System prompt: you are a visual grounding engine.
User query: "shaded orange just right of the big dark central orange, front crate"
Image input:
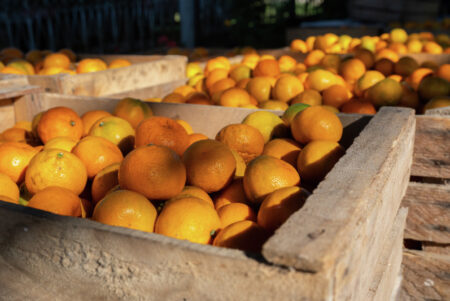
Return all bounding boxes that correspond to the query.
[183,139,236,193]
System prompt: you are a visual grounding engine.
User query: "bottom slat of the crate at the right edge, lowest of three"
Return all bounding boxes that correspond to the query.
[398,250,450,301]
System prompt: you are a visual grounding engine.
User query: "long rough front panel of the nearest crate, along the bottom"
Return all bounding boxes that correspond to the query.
[0,202,327,300]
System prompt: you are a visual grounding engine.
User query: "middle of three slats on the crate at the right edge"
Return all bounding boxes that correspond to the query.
[402,182,450,244]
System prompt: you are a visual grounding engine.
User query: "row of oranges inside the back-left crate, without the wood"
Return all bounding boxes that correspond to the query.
[0,48,131,75]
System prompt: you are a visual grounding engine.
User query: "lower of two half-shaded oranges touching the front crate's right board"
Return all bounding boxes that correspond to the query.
[257,186,310,232]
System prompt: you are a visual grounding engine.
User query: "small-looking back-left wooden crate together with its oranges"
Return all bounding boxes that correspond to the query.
[0,48,186,96]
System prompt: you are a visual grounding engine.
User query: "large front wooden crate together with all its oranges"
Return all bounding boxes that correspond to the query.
[0,86,415,300]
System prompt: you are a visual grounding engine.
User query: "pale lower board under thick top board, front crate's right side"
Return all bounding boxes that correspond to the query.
[366,208,408,301]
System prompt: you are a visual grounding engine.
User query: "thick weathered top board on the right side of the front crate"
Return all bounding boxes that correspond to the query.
[263,108,415,300]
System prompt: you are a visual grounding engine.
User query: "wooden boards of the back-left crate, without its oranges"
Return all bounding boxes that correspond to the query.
[0,55,187,96]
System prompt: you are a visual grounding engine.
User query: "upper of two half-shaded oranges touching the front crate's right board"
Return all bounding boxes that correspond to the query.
[297,140,345,182]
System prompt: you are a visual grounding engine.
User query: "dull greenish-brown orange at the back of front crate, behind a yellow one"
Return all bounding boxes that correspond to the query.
[114,97,153,129]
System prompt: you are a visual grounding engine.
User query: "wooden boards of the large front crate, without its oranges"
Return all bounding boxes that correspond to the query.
[0,93,415,300]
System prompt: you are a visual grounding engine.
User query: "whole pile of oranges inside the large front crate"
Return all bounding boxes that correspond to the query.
[0,98,344,252]
